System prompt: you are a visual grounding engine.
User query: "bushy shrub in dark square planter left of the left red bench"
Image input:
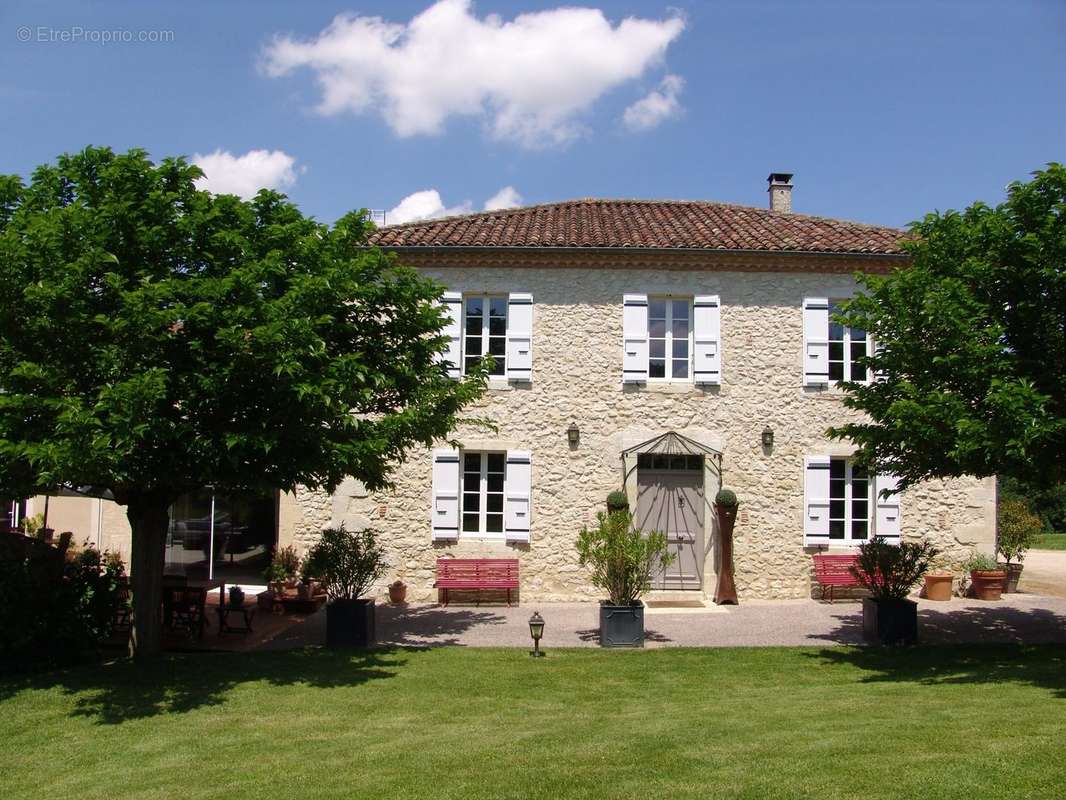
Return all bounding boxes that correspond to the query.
[304,526,387,647]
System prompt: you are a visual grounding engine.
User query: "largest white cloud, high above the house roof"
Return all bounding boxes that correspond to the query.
[262,0,684,147]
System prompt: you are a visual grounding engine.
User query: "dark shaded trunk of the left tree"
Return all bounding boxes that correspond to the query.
[126,495,171,659]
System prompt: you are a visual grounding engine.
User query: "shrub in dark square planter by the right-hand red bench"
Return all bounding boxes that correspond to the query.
[852,537,937,644]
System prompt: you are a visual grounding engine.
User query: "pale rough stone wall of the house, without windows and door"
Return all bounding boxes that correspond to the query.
[279,263,996,602]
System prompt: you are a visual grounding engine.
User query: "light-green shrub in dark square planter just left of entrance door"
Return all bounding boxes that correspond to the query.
[577,511,674,647]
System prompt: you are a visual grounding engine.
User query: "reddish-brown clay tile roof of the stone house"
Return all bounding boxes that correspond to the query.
[371,198,907,255]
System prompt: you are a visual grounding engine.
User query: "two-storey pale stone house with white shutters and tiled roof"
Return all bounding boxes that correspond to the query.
[12,174,996,602]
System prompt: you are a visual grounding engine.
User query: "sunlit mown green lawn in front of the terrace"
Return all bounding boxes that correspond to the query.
[0,646,1066,800]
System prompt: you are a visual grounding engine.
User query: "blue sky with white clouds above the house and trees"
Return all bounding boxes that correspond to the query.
[0,0,1066,225]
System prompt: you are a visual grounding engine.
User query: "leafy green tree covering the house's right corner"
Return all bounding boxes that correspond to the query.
[830,163,1066,486]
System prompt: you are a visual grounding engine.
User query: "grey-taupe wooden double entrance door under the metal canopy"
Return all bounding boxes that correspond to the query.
[633,454,704,591]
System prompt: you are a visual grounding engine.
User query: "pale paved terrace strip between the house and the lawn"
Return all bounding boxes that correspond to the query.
[255,593,1066,650]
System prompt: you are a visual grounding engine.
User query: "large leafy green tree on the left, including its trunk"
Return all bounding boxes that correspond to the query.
[0,147,484,655]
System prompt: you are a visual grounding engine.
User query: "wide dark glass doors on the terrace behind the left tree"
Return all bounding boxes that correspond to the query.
[165,489,277,583]
